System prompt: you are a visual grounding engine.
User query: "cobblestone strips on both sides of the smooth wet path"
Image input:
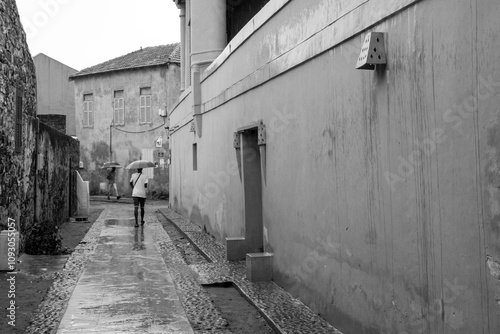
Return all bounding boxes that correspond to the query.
[25,204,341,334]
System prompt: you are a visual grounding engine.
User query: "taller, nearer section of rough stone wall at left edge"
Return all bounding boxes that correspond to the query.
[0,0,36,246]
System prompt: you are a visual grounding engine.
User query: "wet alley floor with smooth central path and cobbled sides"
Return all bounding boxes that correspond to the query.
[20,202,340,334]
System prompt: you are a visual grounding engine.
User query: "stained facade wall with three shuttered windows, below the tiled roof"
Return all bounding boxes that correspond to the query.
[74,65,179,195]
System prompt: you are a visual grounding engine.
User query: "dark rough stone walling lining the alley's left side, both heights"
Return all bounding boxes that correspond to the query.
[0,0,79,253]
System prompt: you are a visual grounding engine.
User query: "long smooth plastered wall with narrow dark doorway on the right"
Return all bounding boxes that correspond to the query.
[170,0,500,333]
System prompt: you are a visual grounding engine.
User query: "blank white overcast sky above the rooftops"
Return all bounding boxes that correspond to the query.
[16,0,180,71]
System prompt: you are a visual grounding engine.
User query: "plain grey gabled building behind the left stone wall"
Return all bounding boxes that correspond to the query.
[33,53,78,136]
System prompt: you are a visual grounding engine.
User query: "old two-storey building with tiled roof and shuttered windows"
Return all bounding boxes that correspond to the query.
[70,44,180,195]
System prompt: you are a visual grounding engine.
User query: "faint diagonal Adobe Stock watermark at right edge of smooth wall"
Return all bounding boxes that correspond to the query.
[384,74,500,192]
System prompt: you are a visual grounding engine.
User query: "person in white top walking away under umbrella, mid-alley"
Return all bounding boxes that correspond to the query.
[125,160,155,227]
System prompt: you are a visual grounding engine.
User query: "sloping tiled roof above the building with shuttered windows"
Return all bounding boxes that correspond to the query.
[69,43,180,80]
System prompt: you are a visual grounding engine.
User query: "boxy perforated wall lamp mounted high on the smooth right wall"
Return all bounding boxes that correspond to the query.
[356,32,387,70]
